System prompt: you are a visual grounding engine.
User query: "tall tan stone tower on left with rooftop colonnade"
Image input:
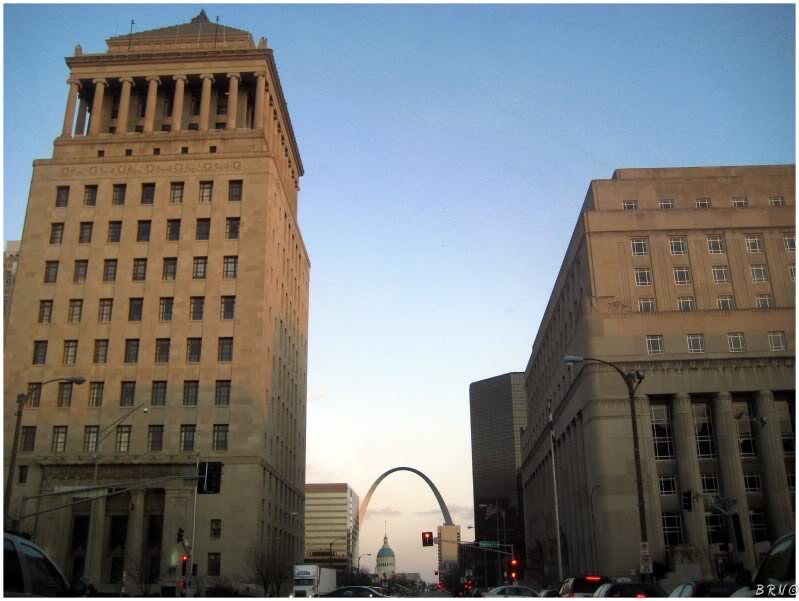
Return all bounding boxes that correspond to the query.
[5,12,310,594]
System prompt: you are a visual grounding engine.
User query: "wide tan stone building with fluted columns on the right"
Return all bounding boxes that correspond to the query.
[522,166,796,580]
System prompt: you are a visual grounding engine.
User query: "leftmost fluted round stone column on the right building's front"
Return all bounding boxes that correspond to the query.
[671,392,713,576]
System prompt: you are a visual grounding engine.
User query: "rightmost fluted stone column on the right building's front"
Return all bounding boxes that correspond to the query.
[753,390,794,541]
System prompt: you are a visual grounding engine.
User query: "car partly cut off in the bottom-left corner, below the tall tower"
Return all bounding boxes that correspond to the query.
[3,532,88,597]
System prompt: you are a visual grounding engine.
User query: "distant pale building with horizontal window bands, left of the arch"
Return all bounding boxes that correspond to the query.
[305,483,360,572]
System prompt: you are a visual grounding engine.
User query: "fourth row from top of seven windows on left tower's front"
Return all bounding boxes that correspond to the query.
[39,296,236,323]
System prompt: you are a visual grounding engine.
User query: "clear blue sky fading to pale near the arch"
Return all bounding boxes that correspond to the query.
[4,4,796,580]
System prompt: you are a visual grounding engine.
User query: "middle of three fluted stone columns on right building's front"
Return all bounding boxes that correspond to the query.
[713,392,759,574]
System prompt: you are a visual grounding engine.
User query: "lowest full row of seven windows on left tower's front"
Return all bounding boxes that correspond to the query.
[19,424,230,453]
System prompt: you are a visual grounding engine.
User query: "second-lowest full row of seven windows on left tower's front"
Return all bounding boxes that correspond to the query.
[26,380,232,409]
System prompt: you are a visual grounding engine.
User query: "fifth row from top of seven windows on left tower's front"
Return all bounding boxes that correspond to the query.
[33,337,238,365]
